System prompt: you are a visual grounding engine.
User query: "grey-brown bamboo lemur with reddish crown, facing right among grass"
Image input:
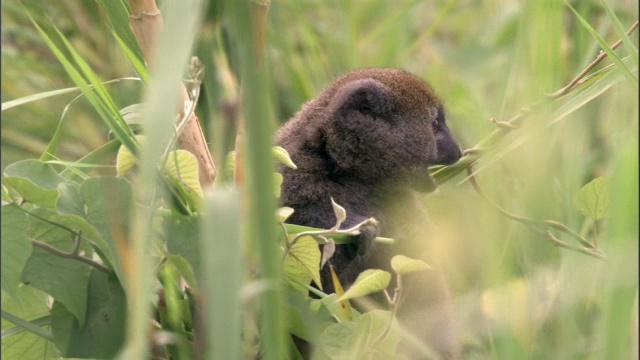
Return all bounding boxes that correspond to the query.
[276,68,461,359]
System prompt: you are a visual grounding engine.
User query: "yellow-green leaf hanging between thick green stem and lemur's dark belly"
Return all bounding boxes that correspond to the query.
[282,236,322,294]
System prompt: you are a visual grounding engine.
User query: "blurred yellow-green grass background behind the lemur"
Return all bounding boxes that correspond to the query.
[1,0,638,359]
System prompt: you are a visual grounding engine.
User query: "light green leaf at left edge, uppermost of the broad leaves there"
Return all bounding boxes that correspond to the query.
[2,159,67,208]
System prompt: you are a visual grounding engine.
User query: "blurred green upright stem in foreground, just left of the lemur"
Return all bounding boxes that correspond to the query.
[225,0,286,360]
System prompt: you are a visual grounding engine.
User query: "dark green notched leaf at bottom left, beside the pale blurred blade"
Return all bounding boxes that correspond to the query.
[51,269,127,359]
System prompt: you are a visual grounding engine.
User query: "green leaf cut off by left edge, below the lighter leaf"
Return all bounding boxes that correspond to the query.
[0,205,32,298]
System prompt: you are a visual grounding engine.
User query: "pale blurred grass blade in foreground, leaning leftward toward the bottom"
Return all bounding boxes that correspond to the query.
[119,0,205,359]
